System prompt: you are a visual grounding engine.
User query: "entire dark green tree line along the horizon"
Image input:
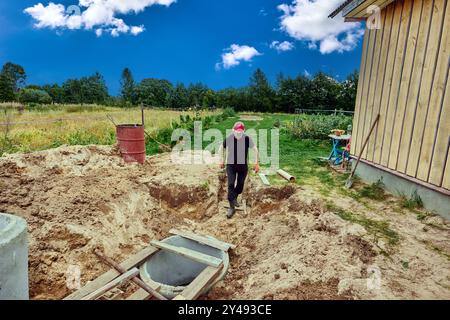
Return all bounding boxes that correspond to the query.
[0,63,358,113]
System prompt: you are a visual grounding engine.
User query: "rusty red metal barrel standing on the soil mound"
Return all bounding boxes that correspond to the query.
[116,124,145,164]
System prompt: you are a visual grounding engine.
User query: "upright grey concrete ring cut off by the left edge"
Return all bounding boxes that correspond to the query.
[0,213,29,300]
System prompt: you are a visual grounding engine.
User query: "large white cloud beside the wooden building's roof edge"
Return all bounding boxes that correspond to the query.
[278,0,364,54]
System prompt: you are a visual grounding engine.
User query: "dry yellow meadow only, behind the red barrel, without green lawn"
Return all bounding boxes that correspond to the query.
[0,105,218,155]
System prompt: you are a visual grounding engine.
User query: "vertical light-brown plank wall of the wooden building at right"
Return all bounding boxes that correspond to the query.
[351,0,450,190]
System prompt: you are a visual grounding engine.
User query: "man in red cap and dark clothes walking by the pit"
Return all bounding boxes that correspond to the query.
[219,122,259,219]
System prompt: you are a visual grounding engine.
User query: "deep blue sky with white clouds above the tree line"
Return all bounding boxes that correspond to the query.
[0,0,363,94]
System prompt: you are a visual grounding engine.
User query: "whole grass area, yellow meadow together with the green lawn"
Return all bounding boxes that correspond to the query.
[0,105,352,192]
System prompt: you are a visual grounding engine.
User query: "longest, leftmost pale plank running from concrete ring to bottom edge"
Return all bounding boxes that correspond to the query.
[64,246,159,300]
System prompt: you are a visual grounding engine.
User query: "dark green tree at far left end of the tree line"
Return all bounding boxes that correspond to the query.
[0,62,27,102]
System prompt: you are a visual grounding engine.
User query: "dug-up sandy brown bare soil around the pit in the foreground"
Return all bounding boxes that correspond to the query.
[0,146,450,299]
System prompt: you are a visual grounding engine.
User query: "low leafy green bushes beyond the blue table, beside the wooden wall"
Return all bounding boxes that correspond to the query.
[288,115,353,140]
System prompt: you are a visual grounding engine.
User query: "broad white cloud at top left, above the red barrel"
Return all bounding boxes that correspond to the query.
[24,0,176,37]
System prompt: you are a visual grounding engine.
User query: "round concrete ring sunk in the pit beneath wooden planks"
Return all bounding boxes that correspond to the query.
[140,236,230,299]
